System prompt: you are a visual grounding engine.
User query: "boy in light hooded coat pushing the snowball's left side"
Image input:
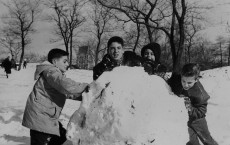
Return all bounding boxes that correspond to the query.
[22,49,88,145]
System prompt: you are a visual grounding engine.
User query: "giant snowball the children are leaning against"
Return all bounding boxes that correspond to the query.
[68,66,188,145]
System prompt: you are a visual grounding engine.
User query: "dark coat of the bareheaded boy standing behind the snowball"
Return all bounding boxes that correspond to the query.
[93,51,141,80]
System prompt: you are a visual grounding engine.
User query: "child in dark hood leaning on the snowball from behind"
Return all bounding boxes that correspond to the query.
[141,42,167,79]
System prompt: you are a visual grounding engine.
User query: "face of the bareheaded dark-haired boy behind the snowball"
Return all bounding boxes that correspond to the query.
[108,42,124,60]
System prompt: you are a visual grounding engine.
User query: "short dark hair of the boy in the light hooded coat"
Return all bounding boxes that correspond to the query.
[48,48,69,63]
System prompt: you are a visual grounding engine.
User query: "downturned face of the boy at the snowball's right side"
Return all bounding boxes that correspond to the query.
[181,76,197,90]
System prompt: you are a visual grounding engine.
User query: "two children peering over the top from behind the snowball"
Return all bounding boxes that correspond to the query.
[93,36,167,80]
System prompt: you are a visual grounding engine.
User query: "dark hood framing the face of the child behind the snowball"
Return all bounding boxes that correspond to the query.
[141,42,161,63]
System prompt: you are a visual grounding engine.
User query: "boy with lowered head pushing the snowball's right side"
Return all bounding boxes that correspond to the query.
[169,63,217,145]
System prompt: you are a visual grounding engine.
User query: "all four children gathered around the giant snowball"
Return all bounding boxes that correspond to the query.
[22,36,217,145]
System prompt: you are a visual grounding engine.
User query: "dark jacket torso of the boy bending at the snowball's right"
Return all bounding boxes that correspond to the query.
[188,81,210,120]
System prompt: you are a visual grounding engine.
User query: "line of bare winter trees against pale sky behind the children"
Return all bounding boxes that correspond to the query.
[0,0,230,72]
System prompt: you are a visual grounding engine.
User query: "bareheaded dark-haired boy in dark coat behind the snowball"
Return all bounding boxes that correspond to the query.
[93,36,141,80]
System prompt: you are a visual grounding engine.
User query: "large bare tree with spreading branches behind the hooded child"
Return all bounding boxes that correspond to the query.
[98,0,205,73]
